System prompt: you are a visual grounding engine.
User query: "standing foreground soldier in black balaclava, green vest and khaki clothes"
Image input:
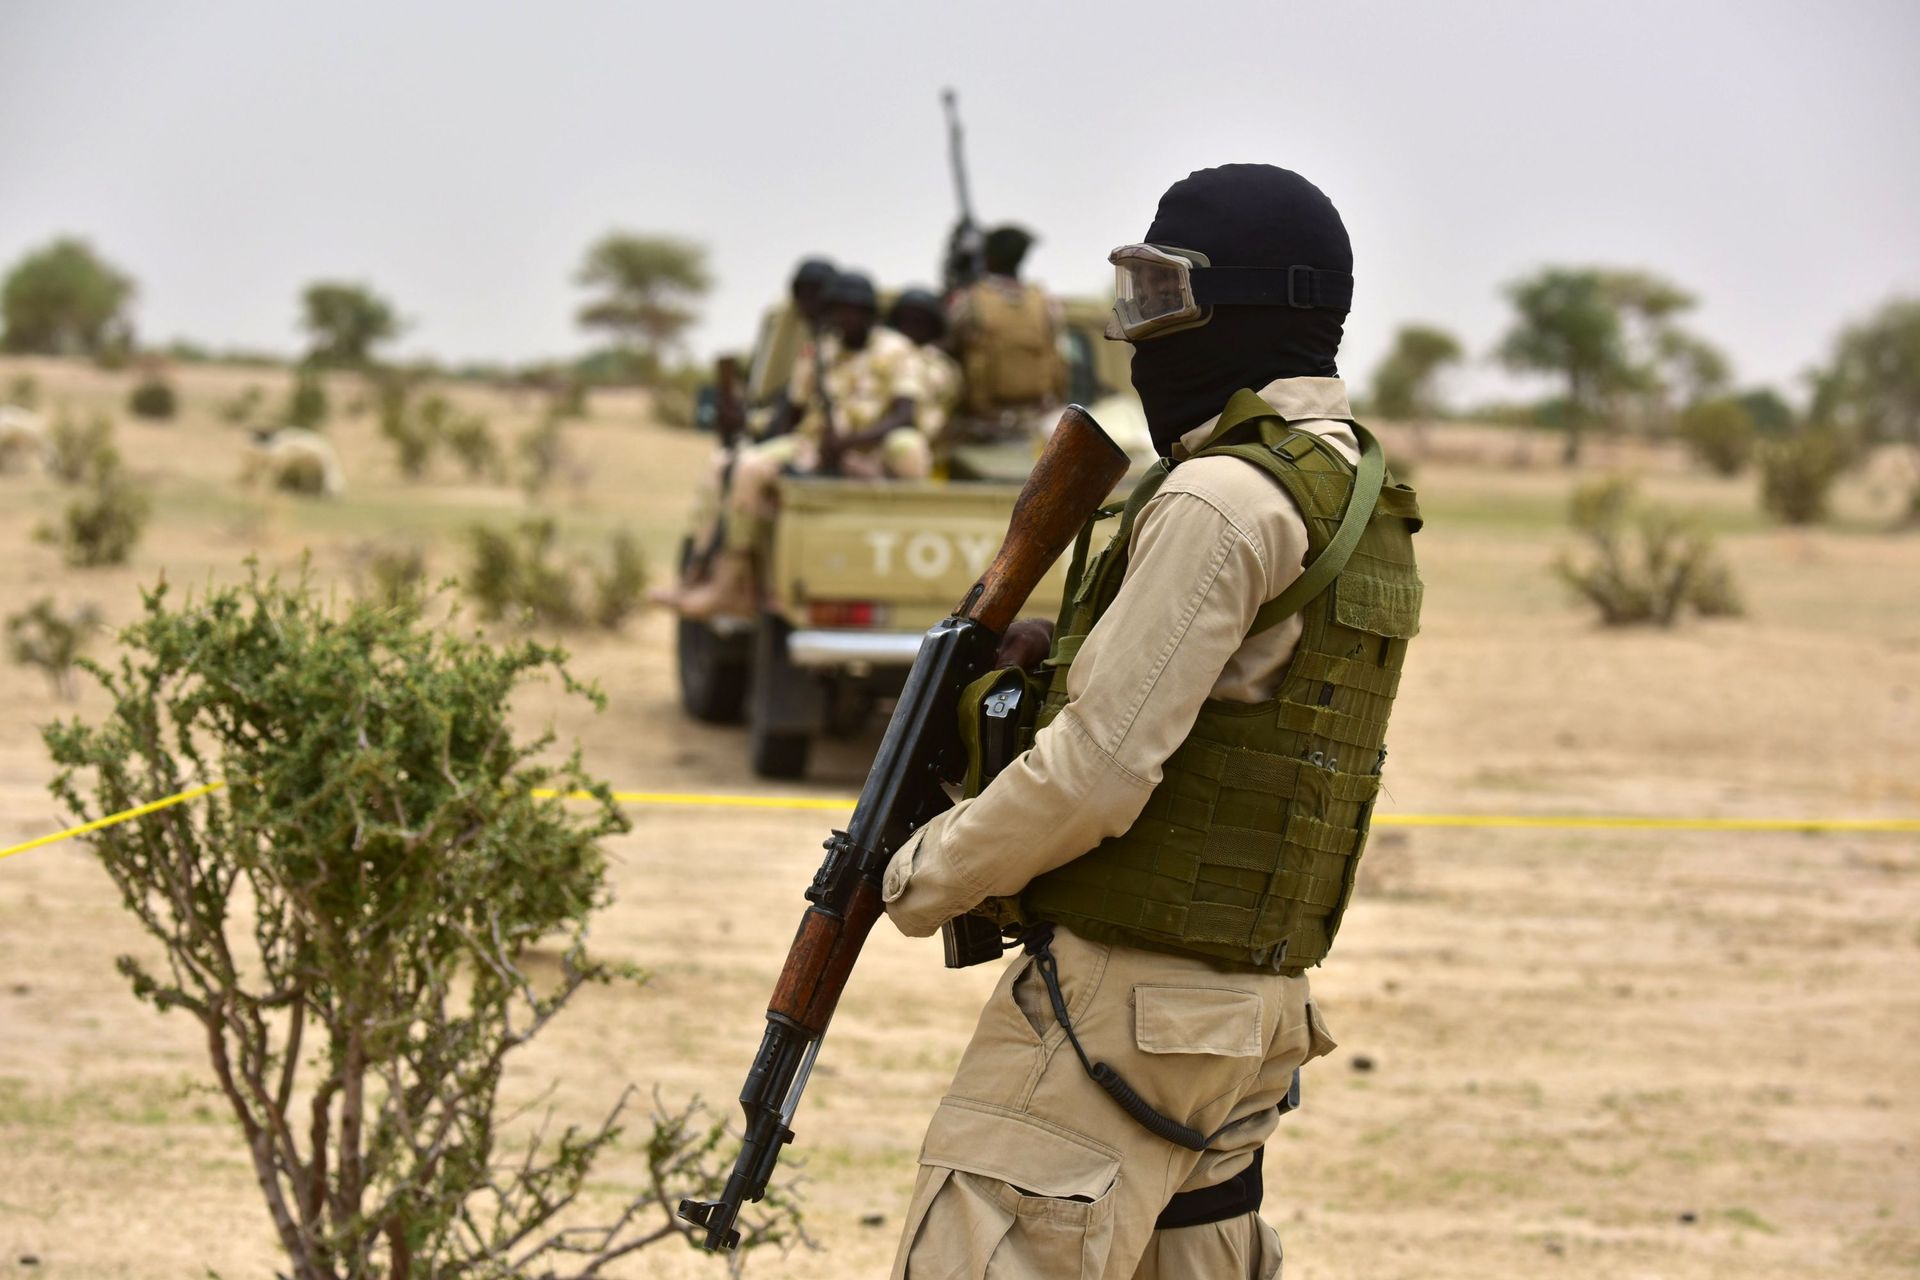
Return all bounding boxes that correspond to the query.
[883,165,1421,1280]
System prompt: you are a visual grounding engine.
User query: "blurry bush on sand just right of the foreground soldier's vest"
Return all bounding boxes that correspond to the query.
[1553,476,1743,628]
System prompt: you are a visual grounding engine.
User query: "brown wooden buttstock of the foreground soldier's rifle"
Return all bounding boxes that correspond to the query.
[956,405,1127,635]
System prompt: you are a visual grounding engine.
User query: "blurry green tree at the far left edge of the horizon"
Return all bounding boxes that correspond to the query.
[0,238,134,355]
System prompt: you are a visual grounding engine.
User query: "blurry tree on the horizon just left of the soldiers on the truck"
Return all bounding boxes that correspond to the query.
[574,230,712,367]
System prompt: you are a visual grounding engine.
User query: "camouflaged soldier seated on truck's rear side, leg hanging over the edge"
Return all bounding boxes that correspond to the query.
[662,273,933,618]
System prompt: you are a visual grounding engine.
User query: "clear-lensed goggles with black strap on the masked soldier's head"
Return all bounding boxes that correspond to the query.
[1106,244,1354,342]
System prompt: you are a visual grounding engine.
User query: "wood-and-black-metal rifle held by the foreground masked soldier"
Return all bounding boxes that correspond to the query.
[680,405,1127,1249]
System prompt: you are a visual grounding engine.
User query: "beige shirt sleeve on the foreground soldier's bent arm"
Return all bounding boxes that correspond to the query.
[881,480,1306,936]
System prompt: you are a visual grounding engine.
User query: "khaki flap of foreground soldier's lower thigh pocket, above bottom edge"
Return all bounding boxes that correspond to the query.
[920,1098,1119,1199]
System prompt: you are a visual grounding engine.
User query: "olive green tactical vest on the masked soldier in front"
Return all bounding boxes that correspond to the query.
[983,391,1421,973]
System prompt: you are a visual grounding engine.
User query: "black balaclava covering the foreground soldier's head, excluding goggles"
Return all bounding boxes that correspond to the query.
[1133,165,1354,455]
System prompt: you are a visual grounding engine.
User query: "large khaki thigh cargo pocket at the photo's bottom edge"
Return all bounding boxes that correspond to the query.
[895,1098,1119,1280]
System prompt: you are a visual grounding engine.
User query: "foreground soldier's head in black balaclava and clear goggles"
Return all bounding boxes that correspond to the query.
[1108,165,1354,453]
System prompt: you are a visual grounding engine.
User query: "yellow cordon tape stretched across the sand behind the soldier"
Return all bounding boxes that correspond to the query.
[0,783,1920,858]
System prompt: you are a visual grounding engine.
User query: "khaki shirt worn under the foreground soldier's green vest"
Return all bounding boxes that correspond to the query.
[881,378,1359,936]
